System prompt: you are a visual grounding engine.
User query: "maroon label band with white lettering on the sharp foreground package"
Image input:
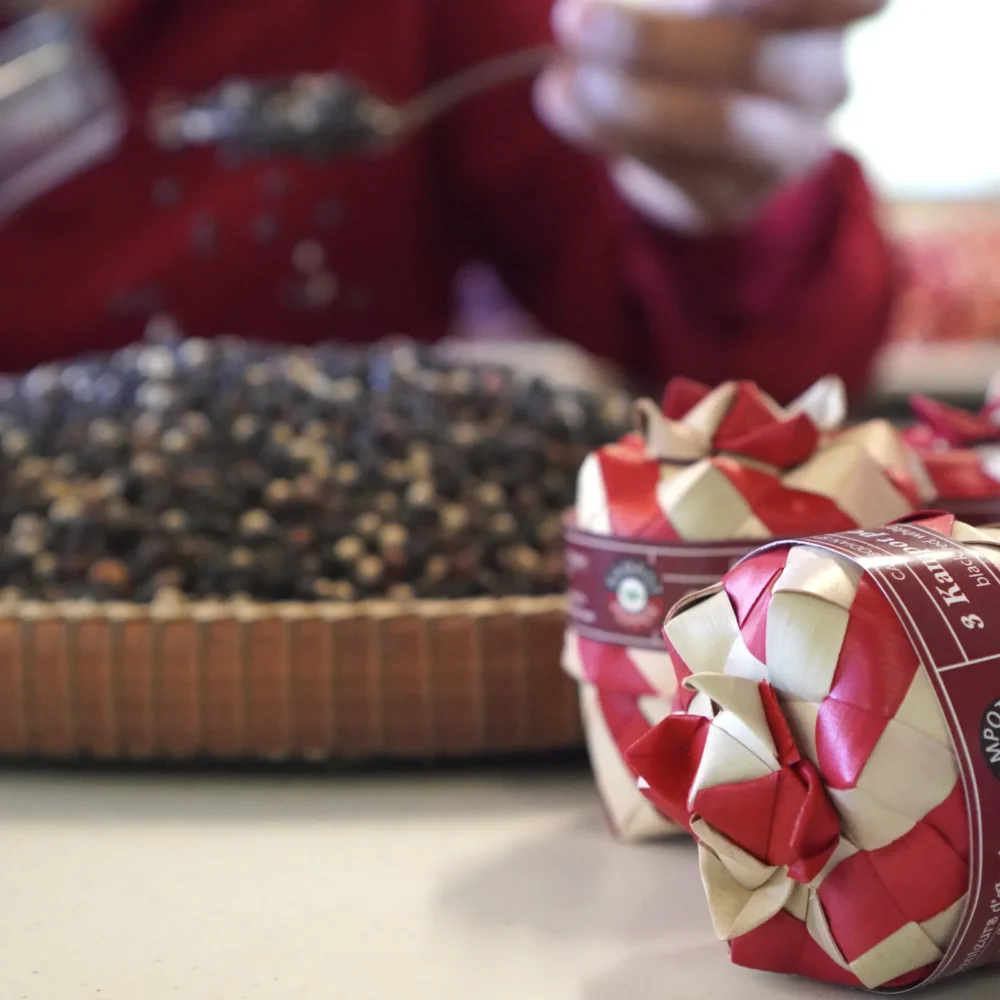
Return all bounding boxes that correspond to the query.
[784,524,1000,993]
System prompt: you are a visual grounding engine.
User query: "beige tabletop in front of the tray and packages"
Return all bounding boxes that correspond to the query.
[0,769,1000,1000]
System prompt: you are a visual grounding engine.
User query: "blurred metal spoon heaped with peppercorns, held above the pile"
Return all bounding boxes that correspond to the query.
[150,47,552,158]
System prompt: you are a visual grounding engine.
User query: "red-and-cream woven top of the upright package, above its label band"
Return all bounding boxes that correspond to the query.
[576,378,932,542]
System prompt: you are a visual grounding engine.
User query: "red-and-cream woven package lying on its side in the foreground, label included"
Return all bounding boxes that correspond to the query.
[629,514,1000,989]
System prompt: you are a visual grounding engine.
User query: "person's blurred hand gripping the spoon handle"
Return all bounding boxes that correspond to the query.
[536,0,886,231]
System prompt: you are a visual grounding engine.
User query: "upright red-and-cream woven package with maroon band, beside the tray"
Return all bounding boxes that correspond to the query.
[563,378,929,840]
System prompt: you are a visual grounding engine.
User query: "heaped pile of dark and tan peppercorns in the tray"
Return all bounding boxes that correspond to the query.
[0,338,629,602]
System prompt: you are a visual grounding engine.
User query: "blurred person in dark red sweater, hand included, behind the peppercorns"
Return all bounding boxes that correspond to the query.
[0,0,895,397]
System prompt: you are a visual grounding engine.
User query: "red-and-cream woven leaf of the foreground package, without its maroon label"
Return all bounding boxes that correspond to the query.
[628,517,1000,989]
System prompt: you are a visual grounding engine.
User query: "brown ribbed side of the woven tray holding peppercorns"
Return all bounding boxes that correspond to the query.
[0,597,582,761]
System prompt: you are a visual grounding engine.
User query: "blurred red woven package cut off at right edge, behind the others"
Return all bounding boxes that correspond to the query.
[905,388,1000,525]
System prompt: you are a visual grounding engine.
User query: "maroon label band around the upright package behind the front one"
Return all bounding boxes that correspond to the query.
[566,525,761,650]
